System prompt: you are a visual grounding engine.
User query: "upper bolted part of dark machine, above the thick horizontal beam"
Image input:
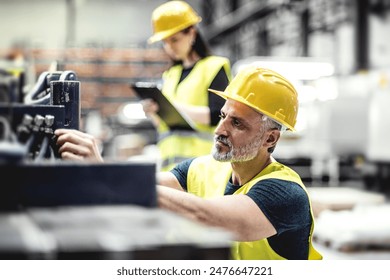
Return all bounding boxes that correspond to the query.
[0,71,80,163]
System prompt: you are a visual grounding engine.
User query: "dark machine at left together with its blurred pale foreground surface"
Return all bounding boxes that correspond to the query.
[0,68,231,260]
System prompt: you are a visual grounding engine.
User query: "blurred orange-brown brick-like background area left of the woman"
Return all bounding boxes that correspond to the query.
[29,48,169,117]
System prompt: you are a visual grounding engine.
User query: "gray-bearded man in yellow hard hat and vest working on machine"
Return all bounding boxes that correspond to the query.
[56,67,322,260]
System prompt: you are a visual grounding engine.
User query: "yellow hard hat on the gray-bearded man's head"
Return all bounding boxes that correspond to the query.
[209,66,298,131]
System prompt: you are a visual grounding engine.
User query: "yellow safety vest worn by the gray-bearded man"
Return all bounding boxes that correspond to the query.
[187,156,322,260]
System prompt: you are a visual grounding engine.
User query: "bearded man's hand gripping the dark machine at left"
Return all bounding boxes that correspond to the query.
[54,129,103,162]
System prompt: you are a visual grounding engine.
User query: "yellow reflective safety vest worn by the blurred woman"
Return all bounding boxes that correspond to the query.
[157,56,231,171]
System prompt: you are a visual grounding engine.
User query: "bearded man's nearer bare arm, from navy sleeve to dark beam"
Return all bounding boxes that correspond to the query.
[157,185,276,241]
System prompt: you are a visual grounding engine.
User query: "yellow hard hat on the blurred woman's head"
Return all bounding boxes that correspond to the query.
[148,1,202,44]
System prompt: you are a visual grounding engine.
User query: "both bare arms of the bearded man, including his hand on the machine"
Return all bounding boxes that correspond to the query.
[55,129,276,241]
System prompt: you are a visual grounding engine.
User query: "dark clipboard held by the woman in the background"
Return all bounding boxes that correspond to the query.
[130,82,195,131]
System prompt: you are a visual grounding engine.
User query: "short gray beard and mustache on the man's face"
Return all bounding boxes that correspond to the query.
[211,132,262,162]
